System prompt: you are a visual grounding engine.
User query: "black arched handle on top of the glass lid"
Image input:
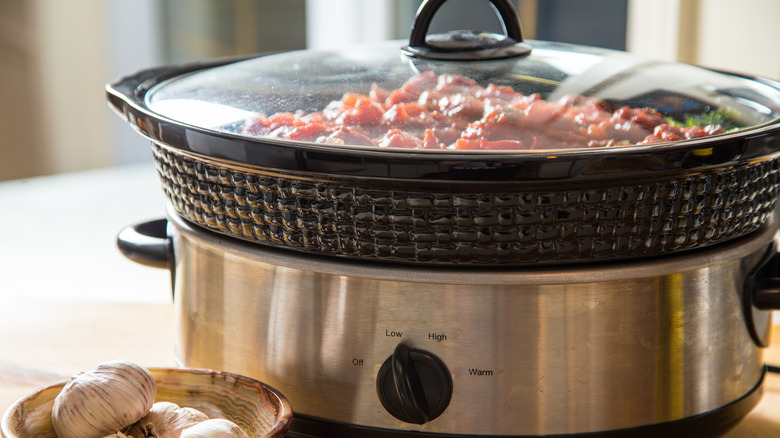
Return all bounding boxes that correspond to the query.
[402,0,531,61]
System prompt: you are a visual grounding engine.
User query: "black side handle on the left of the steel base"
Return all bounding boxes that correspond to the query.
[117,219,172,269]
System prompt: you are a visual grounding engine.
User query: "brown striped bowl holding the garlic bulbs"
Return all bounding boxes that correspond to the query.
[0,368,292,438]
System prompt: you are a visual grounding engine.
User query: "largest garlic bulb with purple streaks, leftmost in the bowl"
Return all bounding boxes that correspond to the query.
[51,360,157,438]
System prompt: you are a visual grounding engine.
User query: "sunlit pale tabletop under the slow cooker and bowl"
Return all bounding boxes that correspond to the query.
[0,165,780,438]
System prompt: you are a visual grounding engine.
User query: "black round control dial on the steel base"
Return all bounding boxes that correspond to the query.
[376,342,452,424]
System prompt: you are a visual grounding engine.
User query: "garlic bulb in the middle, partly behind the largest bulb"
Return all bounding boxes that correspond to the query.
[125,402,208,438]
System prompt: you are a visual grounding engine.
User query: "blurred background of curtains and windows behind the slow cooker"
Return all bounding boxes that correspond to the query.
[0,0,780,180]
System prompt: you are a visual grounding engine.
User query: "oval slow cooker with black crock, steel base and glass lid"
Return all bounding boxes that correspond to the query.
[107,0,780,438]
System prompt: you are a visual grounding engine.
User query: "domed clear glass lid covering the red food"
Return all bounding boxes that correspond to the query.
[146,5,780,152]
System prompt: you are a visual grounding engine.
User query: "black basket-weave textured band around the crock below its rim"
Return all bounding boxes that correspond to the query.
[152,143,780,265]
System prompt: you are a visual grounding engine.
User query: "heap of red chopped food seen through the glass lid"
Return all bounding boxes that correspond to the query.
[241,71,730,150]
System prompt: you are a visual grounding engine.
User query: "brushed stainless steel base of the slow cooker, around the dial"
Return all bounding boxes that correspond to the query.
[166,214,774,436]
